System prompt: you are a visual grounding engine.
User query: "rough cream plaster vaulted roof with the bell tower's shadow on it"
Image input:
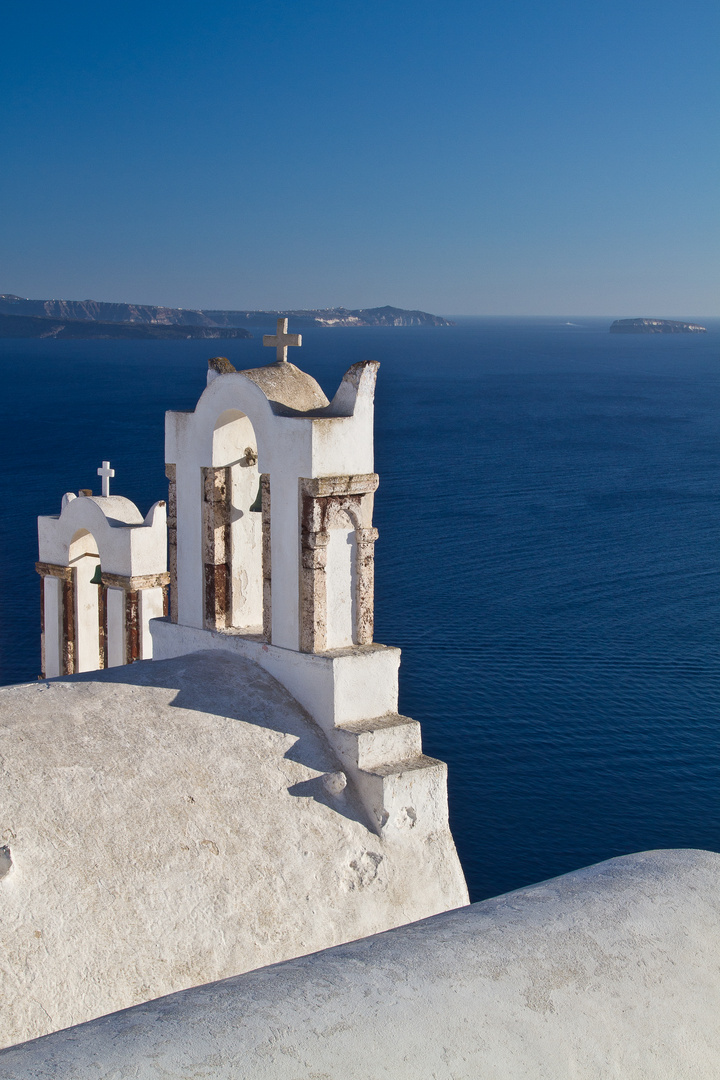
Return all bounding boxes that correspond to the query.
[0,651,464,1045]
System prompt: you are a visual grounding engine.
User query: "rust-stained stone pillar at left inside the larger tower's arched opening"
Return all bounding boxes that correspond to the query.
[202,465,232,630]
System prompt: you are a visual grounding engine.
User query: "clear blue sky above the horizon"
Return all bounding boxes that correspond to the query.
[0,0,720,316]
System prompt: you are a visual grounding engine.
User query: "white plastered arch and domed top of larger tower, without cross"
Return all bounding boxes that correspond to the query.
[165,362,378,649]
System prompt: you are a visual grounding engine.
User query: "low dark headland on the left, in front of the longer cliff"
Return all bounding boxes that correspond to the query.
[0,313,253,341]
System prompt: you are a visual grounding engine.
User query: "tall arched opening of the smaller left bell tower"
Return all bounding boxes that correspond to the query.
[68,529,105,672]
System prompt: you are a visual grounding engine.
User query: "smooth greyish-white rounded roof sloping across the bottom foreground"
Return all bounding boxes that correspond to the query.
[0,850,720,1080]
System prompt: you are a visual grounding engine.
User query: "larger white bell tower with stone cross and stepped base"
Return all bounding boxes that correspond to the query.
[151,320,447,835]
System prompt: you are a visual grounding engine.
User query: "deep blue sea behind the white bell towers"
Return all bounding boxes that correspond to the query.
[0,319,720,900]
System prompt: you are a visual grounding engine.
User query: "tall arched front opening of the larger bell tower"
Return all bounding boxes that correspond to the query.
[203,409,263,634]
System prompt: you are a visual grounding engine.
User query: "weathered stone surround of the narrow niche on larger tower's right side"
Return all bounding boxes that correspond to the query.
[300,473,378,652]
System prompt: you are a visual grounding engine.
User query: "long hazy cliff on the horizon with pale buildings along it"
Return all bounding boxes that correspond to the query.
[0,293,452,326]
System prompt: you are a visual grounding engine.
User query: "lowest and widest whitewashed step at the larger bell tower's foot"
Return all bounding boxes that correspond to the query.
[354,754,448,835]
